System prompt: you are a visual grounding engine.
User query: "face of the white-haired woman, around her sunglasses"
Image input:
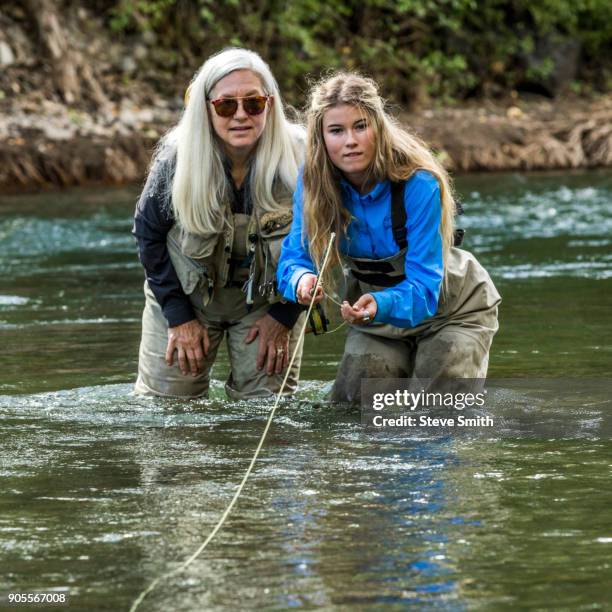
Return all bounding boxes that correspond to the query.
[208,70,272,159]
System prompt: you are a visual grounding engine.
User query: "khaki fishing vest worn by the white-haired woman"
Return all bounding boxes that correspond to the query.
[167,179,293,309]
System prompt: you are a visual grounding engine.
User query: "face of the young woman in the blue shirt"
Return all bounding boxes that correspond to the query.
[323,104,376,190]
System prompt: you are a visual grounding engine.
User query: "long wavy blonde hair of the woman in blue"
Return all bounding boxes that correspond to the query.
[304,72,456,282]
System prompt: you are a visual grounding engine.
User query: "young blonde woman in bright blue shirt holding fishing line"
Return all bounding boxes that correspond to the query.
[277,73,501,402]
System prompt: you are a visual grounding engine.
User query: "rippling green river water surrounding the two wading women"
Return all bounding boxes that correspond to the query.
[0,172,612,610]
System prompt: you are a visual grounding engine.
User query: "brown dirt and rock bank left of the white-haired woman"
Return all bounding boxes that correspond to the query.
[0,101,170,193]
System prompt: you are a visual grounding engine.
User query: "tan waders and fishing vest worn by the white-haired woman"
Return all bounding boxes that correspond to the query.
[135,203,304,400]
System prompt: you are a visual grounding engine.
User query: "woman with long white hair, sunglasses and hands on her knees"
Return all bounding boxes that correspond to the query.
[133,48,304,399]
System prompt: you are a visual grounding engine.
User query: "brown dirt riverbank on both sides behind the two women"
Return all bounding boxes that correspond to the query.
[0,96,612,193]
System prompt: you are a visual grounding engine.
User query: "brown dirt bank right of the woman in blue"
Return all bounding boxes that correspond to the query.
[416,96,612,172]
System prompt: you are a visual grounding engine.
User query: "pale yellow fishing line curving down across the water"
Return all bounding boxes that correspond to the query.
[130,232,336,612]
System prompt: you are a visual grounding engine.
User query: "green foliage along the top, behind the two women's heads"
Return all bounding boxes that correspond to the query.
[105,0,612,103]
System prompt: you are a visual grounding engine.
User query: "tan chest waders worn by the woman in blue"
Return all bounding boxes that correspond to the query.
[331,183,501,403]
